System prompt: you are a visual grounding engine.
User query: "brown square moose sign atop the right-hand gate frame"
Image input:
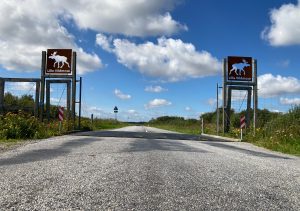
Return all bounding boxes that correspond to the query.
[227,56,252,81]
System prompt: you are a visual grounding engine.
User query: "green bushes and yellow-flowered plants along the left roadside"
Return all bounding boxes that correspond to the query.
[0,93,128,144]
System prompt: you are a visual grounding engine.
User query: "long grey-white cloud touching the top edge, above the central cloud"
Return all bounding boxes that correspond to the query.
[65,0,187,36]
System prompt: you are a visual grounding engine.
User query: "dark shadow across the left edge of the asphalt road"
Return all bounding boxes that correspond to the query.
[0,139,99,166]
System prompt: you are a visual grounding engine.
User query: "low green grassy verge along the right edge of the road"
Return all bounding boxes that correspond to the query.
[150,107,300,156]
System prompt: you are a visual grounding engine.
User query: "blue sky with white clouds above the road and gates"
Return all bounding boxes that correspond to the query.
[0,0,300,121]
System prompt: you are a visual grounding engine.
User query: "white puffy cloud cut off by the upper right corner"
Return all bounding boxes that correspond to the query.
[261,1,300,46]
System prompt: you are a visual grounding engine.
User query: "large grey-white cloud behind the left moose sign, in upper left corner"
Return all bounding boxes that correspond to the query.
[0,0,102,74]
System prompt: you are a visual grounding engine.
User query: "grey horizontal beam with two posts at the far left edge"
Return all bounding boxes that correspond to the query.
[0,78,41,117]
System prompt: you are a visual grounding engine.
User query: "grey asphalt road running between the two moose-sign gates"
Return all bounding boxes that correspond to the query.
[0,127,300,210]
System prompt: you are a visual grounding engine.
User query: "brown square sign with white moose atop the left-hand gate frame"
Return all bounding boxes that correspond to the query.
[46,49,72,74]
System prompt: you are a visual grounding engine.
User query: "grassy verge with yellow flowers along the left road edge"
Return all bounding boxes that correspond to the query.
[0,112,129,151]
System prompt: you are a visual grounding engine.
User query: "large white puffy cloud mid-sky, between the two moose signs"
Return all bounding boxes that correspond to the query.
[98,37,221,82]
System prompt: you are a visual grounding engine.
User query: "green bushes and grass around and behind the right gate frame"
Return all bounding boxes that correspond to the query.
[149,106,300,156]
